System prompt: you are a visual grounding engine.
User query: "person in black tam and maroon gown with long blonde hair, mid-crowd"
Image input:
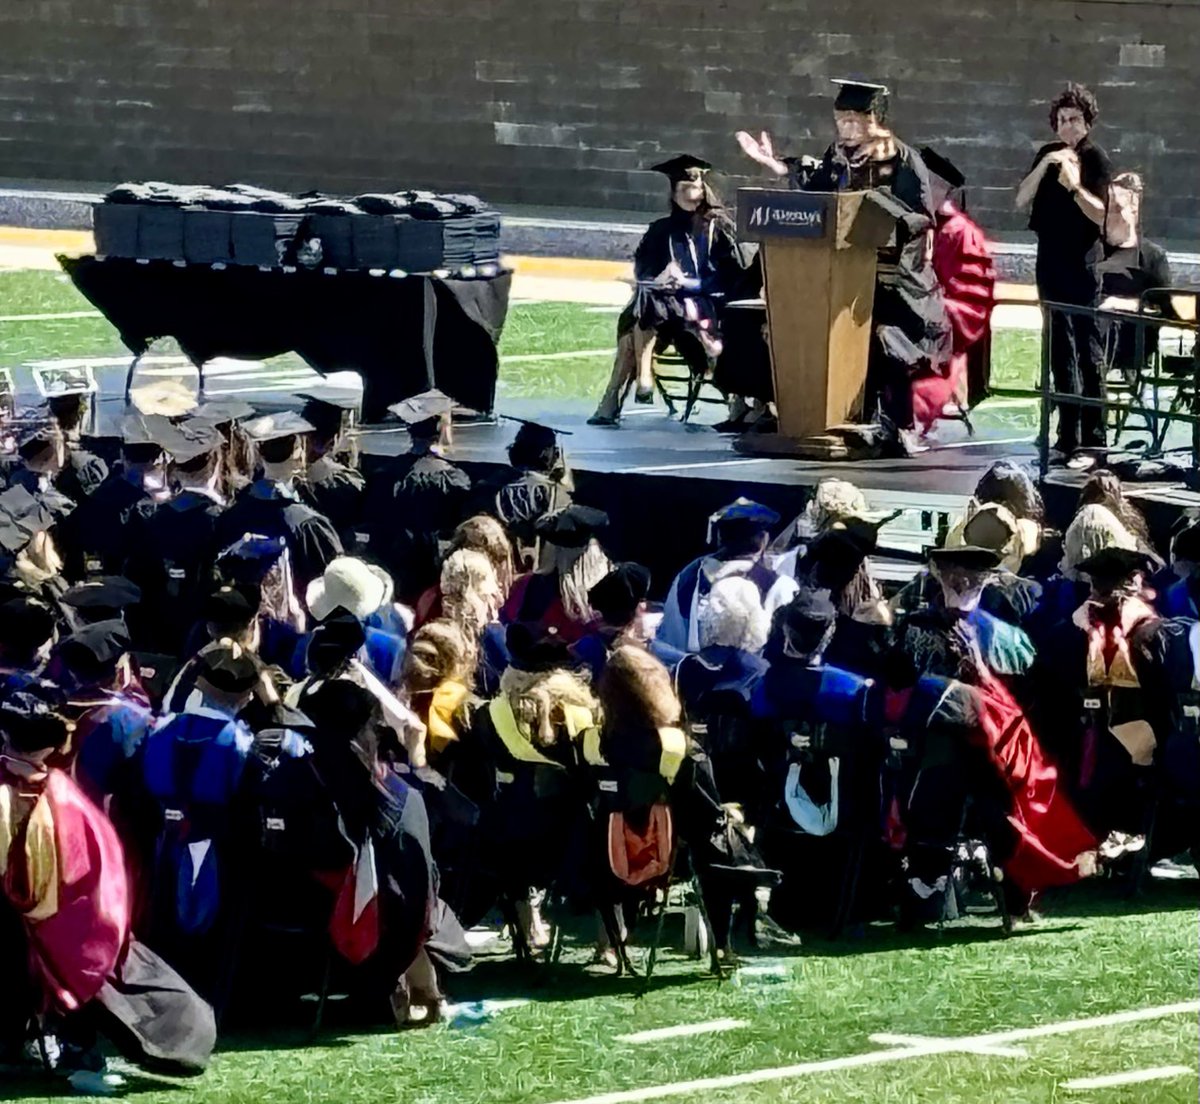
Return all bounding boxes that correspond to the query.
[500,505,612,644]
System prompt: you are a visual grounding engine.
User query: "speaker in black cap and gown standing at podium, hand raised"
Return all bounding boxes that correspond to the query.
[738,80,952,445]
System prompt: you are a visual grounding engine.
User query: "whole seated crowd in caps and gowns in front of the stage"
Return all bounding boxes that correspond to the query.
[0,384,1200,1091]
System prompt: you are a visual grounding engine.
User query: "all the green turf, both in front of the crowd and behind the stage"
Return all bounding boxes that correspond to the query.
[0,272,1200,1104]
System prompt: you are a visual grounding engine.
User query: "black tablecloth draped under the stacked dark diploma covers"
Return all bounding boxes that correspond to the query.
[59,257,512,421]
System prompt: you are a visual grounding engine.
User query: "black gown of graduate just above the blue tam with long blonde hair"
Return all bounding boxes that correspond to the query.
[216,479,342,588]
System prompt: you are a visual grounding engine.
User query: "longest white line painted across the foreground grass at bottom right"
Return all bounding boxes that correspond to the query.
[540,1001,1200,1104]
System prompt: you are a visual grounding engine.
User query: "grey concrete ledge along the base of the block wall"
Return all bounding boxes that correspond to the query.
[0,186,1200,287]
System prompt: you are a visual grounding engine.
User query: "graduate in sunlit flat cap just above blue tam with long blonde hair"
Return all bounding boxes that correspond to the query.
[216,410,342,600]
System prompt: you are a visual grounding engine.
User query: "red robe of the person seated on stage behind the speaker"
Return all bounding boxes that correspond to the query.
[912,200,996,432]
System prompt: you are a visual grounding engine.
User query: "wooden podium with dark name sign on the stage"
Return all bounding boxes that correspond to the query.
[738,188,895,438]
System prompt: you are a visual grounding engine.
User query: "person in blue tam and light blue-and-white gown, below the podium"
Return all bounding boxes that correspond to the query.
[655,498,798,652]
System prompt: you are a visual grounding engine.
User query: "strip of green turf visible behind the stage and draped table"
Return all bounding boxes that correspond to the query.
[0,272,1039,432]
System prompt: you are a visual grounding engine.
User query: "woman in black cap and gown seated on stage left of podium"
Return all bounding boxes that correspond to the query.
[588,155,748,426]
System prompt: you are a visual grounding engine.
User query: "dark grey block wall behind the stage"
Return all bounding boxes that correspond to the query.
[0,0,1200,245]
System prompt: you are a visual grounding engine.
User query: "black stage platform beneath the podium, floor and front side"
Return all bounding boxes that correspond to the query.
[360,401,1200,592]
